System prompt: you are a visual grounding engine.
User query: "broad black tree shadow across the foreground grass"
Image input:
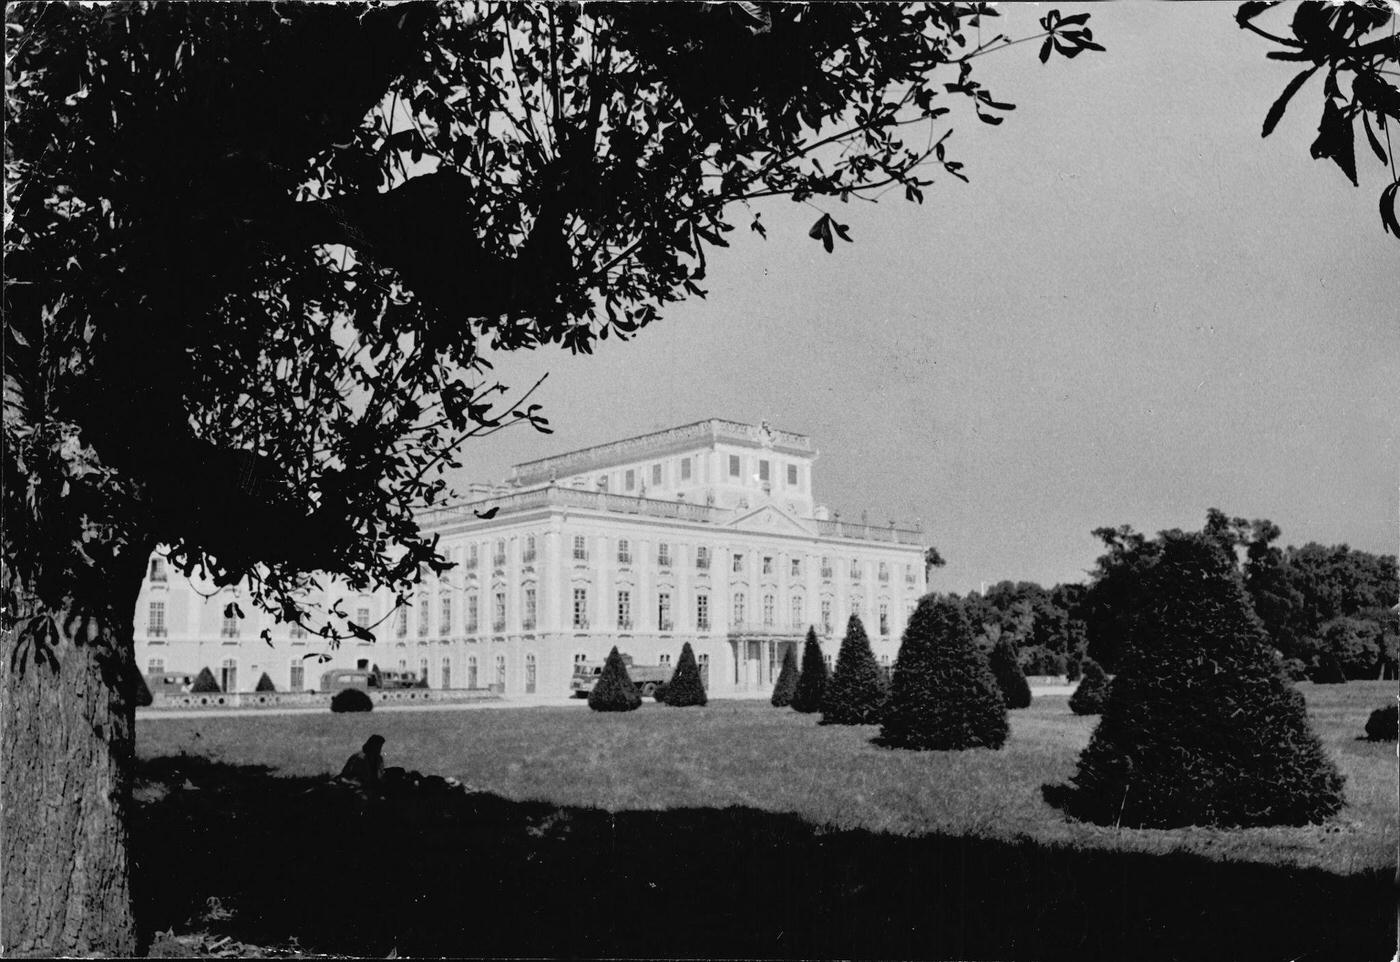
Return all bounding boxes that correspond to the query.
[134,756,1394,959]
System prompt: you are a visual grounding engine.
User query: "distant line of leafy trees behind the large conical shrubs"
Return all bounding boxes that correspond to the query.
[960,508,1400,682]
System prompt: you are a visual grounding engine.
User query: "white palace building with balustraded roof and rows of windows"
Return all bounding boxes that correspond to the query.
[134,419,927,696]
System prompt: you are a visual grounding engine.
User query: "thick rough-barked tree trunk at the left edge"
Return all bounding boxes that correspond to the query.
[0,549,146,958]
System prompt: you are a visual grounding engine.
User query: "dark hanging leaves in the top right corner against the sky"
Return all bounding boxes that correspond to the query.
[1235,0,1400,239]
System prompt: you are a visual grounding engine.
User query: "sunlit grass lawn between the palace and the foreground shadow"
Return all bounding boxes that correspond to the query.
[137,682,1397,874]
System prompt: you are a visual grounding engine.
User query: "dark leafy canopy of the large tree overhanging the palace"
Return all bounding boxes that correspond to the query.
[4,1,1099,639]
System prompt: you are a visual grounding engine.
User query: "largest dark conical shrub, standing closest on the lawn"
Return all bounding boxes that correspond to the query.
[1046,532,1343,828]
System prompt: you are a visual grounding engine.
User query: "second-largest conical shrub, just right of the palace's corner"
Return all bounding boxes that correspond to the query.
[878,595,1009,751]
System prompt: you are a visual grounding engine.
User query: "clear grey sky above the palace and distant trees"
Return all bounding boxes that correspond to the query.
[445,3,1400,591]
